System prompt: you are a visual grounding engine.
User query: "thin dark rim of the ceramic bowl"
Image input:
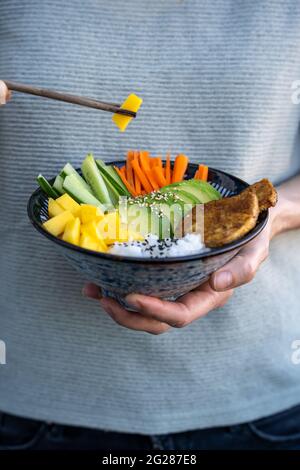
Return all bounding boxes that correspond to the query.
[27,160,269,264]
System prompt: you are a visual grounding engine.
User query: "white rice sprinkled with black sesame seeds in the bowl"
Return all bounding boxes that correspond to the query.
[109,233,207,258]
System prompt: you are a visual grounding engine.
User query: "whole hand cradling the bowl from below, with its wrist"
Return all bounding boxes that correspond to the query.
[83,193,280,334]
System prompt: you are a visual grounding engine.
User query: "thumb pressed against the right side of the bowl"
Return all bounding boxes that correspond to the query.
[210,233,269,292]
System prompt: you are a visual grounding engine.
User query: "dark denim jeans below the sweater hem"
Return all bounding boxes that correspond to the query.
[0,405,300,451]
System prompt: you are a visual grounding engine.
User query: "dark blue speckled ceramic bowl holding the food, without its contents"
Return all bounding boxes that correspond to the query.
[28,161,268,303]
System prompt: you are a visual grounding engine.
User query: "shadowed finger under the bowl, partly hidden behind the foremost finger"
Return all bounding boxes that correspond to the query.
[100,297,170,335]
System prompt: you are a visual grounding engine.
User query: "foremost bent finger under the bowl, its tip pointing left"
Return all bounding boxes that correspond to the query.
[126,282,231,328]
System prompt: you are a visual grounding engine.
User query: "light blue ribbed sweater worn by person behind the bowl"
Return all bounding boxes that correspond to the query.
[0,0,300,434]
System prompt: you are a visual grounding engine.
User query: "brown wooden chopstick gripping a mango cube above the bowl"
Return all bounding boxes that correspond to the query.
[4,80,136,118]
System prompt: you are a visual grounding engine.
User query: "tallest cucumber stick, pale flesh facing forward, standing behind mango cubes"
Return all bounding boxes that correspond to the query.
[81,154,113,205]
